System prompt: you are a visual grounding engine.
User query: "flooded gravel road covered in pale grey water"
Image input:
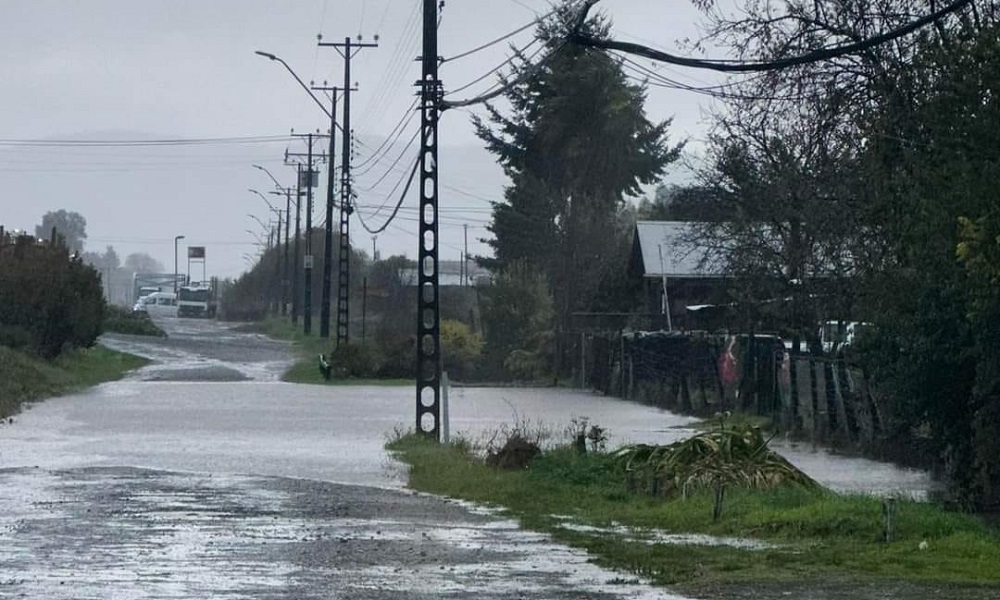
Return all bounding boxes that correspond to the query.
[0,320,930,599]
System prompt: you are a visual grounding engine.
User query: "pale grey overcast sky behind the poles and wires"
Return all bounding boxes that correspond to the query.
[0,0,716,277]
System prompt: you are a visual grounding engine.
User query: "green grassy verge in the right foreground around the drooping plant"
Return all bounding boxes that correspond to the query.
[387,435,1000,598]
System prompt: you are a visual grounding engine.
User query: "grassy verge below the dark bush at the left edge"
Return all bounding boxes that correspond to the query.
[0,345,148,417]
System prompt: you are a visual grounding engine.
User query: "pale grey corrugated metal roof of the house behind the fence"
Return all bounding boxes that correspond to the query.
[635,221,722,279]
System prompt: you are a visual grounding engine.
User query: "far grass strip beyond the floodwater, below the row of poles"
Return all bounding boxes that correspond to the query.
[238,318,413,385]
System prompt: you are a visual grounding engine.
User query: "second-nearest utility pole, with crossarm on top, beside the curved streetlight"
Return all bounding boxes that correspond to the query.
[319,37,378,348]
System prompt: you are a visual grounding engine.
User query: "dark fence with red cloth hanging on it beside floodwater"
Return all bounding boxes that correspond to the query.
[586,332,894,450]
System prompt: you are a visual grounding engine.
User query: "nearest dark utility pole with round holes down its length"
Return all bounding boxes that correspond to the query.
[417,0,441,440]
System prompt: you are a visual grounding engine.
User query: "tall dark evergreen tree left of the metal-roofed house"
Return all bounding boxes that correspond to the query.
[474,2,681,372]
